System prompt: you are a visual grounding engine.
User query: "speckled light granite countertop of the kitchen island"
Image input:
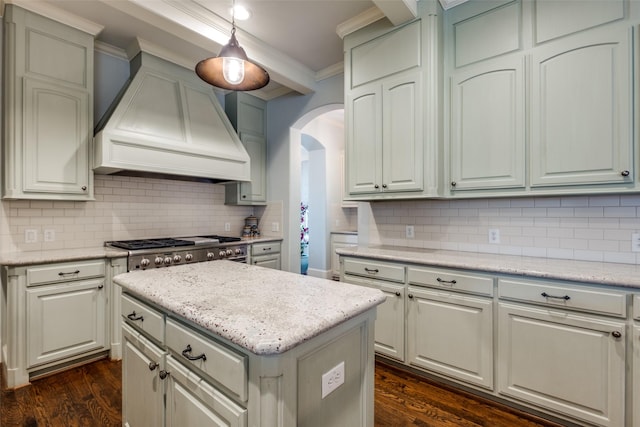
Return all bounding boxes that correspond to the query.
[113,261,385,355]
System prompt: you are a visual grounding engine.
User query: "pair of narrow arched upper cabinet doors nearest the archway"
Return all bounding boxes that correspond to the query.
[346,70,424,196]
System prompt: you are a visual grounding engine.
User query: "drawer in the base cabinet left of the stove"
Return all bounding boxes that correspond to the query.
[27,260,105,286]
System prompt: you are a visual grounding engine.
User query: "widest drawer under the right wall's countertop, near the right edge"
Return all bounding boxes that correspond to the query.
[498,279,627,317]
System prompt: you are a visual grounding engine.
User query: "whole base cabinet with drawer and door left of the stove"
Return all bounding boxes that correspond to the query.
[1,259,111,388]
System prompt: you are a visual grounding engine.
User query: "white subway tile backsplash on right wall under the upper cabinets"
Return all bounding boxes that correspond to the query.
[371,195,640,264]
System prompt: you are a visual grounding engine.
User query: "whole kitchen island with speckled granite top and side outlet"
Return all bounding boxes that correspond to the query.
[114,261,385,427]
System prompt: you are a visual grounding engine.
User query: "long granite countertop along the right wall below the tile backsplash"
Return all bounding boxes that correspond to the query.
[336,246,640,288]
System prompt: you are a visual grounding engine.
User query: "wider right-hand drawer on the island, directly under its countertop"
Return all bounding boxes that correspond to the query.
[167,319,248,402]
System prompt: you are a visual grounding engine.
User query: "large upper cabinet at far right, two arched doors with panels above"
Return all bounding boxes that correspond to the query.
[445,0,638,197]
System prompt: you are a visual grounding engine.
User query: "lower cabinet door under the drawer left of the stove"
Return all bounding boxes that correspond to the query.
[27,278,108,368]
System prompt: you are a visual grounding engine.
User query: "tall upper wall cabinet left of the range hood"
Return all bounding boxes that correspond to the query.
[3,4,94,200]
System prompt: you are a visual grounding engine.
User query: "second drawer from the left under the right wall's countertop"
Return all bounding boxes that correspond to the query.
[407,267,493,296]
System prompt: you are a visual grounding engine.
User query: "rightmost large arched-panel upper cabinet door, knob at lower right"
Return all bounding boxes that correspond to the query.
[530,27,633,187]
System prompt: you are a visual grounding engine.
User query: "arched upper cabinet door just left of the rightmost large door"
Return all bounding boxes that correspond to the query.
[449,57,526,192]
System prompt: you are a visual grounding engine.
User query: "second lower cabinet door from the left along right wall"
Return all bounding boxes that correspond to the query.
[407,286,493,390]
